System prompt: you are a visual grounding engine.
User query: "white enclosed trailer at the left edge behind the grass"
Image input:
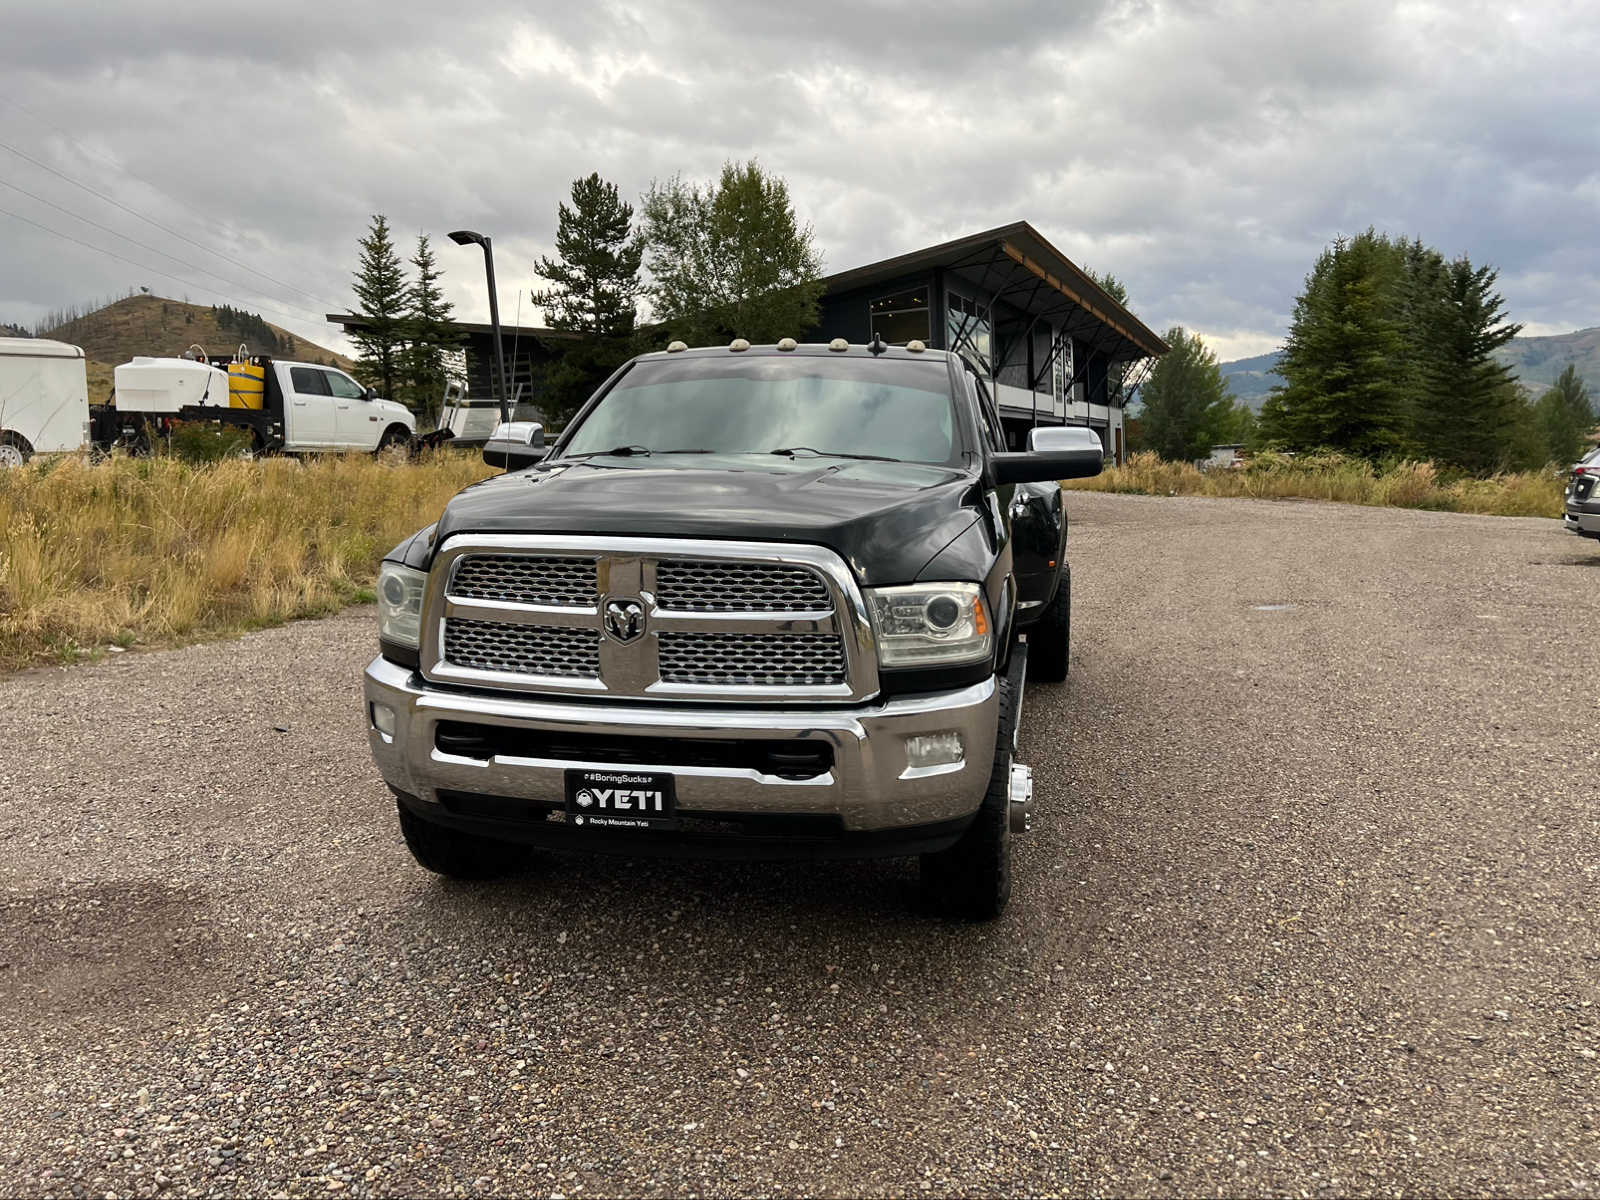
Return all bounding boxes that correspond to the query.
[0,338,90,467]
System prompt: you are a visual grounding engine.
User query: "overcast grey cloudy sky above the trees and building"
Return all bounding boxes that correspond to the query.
[0,0,1600,358]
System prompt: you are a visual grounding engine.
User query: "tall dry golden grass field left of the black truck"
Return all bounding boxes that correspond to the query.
[0,453,493,670]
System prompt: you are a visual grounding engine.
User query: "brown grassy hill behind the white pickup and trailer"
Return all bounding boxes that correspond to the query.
[40,296,352,403]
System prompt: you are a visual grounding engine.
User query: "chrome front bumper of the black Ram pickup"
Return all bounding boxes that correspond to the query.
[365,658,998,832]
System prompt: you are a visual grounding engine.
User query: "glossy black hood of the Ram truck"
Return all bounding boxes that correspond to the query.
[434,456,979,586]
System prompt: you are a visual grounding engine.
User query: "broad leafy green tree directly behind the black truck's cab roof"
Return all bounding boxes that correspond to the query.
[642,160,822,344]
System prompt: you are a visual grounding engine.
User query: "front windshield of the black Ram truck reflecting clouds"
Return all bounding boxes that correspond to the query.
[562,355,957,464]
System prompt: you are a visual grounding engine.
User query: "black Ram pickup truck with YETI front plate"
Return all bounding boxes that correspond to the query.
[365,339,1102,918]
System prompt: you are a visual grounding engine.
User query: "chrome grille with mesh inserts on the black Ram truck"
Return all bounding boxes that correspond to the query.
[419,533,878,704]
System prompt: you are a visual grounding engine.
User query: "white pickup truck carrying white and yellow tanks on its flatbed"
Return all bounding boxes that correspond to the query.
[101,347,416,454]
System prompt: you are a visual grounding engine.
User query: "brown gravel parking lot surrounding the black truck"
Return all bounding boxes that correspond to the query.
[0,494,1600,1195]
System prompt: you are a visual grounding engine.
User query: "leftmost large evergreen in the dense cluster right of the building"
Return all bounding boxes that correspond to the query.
[1261,230,1413,459]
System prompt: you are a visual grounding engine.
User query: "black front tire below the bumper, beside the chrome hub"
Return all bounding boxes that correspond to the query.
[920,678,1016,922]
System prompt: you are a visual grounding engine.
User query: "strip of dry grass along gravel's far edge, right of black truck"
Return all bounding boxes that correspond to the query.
[1066,453,1565,517]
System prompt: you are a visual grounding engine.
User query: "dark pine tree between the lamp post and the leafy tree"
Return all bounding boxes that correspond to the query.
[533,173,645,421]
